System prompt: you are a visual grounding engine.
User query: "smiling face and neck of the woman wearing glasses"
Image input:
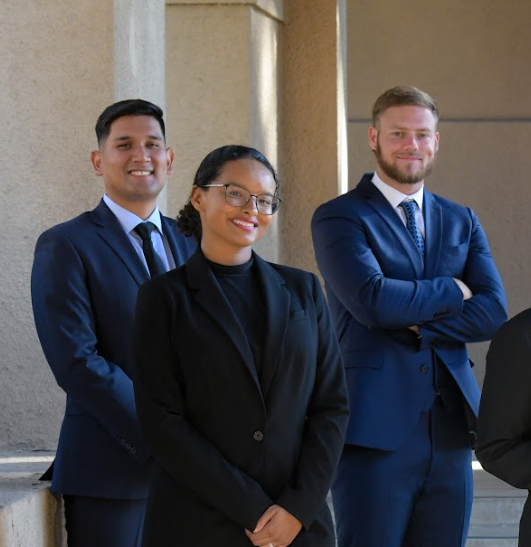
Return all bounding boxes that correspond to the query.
[191,158,276,265]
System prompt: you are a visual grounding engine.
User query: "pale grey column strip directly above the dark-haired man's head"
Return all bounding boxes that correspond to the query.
[114,0,170,212]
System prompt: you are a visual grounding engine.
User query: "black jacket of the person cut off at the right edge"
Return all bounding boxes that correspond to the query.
[476,309,531,547]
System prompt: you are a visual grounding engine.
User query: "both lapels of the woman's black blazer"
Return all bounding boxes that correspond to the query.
[186,247,290,398]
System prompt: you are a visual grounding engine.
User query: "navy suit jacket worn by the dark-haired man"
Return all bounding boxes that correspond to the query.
[31,201,195,499]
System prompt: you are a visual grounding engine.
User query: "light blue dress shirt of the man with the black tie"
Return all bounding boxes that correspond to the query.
[103,194,175,272]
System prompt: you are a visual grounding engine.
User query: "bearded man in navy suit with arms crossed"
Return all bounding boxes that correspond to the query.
[312,87,506,547]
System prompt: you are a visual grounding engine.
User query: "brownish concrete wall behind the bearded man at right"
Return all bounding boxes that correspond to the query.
[348,0,531,383]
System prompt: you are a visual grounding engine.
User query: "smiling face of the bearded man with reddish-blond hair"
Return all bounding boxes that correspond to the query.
[369,105,439,194]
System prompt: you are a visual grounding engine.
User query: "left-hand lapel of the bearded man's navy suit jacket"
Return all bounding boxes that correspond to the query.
[357,175,424,279]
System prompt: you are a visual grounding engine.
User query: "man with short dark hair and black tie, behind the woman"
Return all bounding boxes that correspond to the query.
[31,99,195,547]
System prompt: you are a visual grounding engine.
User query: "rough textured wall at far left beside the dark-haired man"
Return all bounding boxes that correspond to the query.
[0,0,112,448]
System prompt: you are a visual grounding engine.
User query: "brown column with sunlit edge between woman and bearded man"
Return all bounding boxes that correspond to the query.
[282,0,347,271]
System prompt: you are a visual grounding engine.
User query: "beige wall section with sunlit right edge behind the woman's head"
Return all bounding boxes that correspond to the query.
[166,1,279,260]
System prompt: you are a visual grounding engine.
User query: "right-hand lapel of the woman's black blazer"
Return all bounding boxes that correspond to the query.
[253,253,290,398]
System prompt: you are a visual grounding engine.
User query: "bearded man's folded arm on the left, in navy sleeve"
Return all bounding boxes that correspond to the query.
[312,210,463,329]
